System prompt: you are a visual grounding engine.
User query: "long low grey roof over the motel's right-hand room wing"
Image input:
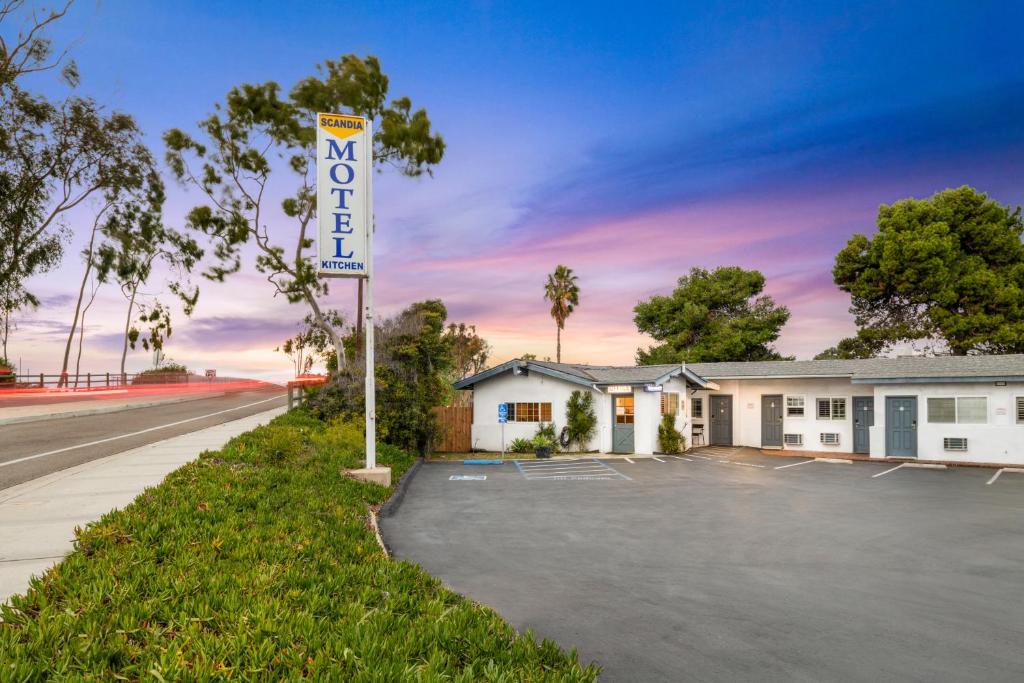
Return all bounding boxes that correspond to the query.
[686,353,1024,384]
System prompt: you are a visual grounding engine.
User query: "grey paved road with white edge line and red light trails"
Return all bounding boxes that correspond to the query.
[0,385,286,489]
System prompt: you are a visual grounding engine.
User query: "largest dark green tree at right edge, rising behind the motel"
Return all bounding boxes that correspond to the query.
[833,186,1024,355]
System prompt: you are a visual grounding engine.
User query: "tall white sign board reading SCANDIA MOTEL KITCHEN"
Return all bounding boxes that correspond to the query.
[316,114,374,278]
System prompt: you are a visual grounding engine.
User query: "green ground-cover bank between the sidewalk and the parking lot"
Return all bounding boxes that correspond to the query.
[0,412,598,682]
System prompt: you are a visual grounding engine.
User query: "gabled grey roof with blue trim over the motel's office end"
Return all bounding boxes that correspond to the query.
[453,358,708,389]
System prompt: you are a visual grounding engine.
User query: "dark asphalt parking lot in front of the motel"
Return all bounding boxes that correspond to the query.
[381,449,1024,681]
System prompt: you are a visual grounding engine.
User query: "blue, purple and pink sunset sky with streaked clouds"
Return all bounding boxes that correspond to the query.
[11,0,1024,377]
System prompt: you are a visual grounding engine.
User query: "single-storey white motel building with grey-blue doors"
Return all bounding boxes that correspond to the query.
[455,354,1024,464]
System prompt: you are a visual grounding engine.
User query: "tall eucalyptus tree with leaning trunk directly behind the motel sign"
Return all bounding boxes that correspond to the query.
[164,54,444,370]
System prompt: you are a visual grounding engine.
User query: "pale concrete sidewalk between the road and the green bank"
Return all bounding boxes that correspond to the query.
[0,408,285,602]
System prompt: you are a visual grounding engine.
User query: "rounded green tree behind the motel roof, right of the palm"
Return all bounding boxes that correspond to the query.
[633,266,790,365]
